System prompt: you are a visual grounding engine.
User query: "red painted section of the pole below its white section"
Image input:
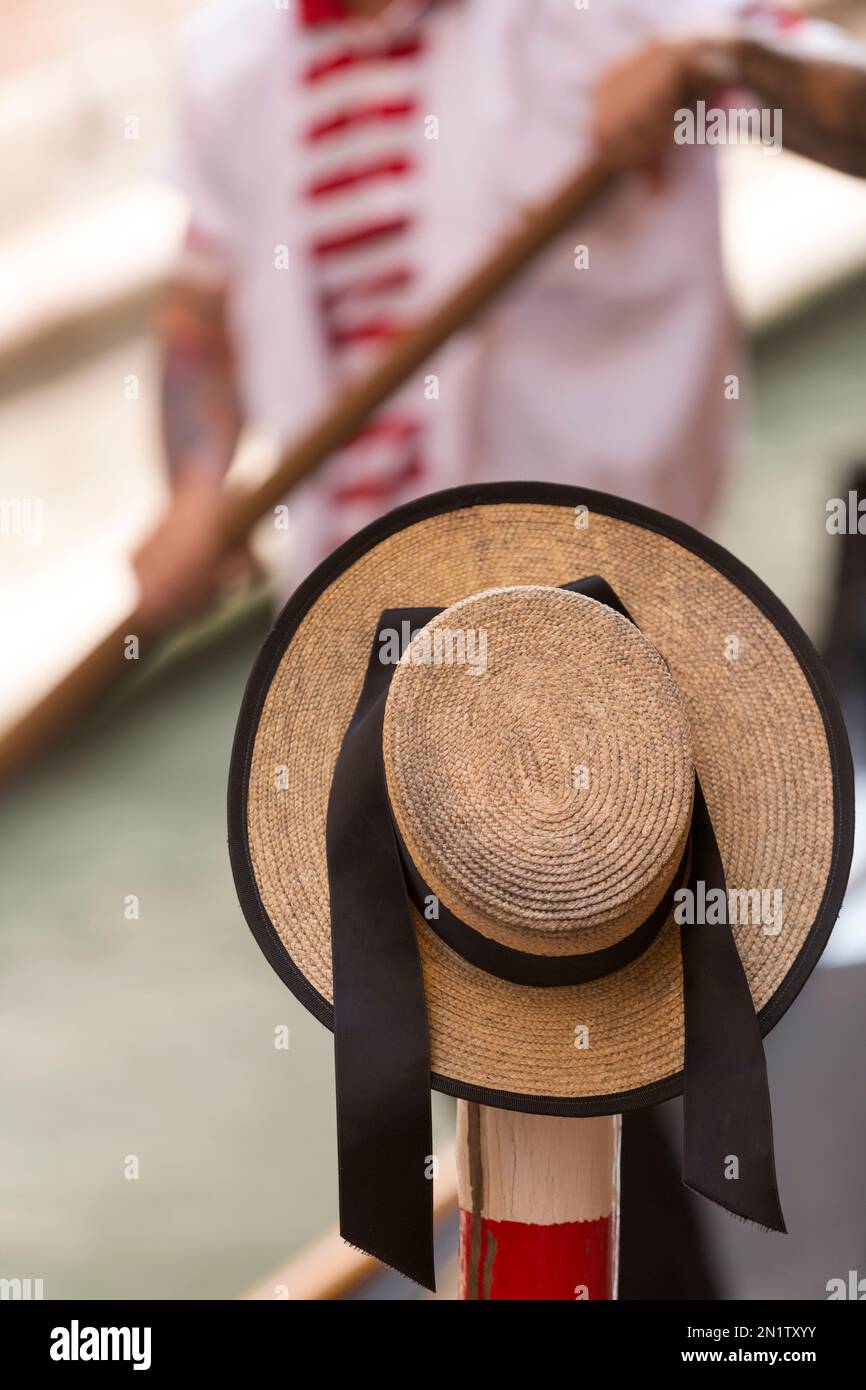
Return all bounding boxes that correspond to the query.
[460,1211,614,1302]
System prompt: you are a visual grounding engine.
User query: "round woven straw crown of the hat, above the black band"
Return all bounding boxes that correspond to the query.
[384,585,694,955]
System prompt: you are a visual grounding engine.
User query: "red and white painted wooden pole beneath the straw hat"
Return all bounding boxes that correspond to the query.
[457,1101,621,1302]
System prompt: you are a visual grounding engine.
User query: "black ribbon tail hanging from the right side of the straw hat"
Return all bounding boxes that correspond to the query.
[681,780,785,1233]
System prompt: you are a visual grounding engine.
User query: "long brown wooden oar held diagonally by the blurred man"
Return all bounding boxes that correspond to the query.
[0,154,613,778]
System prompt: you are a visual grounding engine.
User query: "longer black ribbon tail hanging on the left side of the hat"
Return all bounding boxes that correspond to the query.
[327,609,439,1290]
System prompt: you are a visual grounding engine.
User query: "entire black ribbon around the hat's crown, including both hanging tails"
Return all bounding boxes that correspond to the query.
[327,575,784,1289]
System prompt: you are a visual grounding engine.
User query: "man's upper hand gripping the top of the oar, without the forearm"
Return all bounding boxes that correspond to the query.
[594,40,696,182]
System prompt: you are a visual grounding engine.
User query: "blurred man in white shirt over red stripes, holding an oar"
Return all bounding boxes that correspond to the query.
[136,0,866,621]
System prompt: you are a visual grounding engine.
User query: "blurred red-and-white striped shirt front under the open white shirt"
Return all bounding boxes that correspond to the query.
[292,0,444,550]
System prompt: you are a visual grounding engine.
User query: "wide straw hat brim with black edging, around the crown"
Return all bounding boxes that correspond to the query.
[228,482,853,1115]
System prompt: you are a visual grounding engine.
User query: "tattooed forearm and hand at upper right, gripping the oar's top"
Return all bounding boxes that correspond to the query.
[595,26,866,178]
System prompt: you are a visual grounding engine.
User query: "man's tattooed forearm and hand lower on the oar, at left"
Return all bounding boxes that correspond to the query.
[133,284,242,630]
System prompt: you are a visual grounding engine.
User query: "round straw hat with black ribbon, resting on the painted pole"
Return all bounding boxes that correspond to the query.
[229,484,853,1282]
